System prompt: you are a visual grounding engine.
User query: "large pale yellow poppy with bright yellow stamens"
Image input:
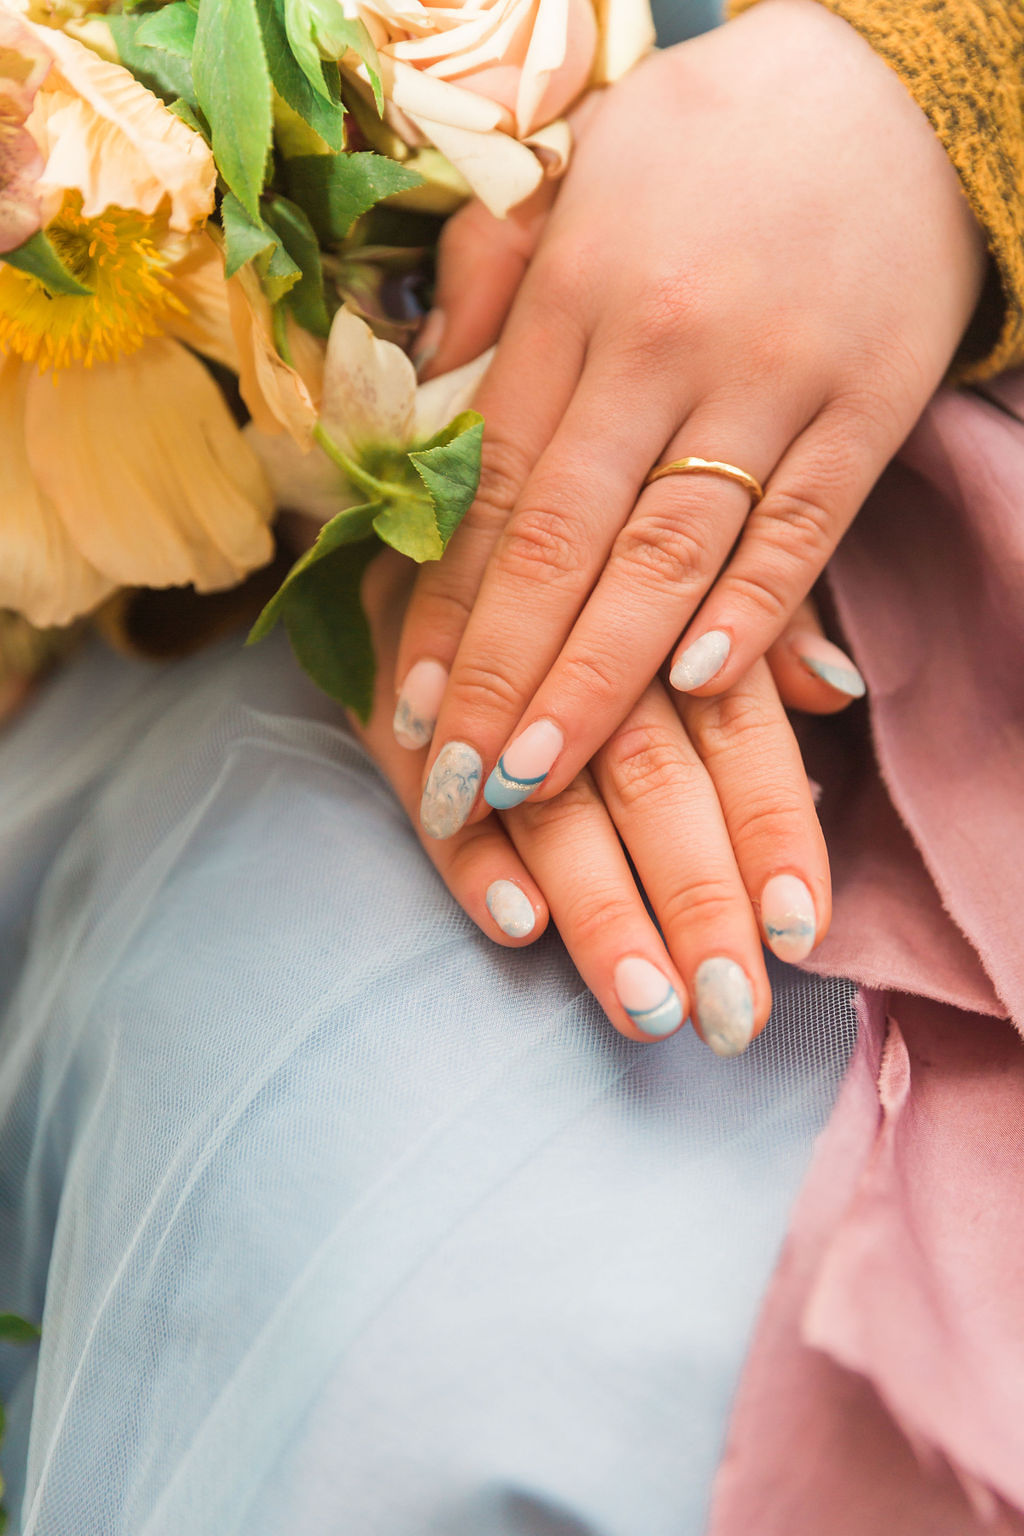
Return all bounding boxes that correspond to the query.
[0,18,291,625]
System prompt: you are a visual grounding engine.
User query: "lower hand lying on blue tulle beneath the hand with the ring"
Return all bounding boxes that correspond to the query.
[361,553,841,1055]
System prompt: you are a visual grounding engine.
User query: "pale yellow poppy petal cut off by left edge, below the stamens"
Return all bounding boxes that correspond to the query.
[0,356,114,628]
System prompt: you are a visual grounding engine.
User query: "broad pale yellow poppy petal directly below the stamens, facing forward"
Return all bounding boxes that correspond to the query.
[25,338,273,591]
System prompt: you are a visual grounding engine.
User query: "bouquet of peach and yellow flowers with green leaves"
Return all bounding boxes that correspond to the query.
[0,0,651,714]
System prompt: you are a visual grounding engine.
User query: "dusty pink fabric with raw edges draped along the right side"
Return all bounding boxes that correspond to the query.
[709,375,1024,1536]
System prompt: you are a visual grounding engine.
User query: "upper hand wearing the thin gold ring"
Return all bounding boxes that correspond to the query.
[398,0,986,836]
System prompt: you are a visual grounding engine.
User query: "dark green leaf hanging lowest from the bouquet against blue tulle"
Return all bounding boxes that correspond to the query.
[282,539,381,723]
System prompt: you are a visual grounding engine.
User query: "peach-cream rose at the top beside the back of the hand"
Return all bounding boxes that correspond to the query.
[318,0,654,214]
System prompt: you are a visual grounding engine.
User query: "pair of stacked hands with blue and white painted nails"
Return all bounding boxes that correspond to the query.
[353,0,986,1055]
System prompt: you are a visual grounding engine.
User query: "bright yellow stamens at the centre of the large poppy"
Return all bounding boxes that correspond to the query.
[0,194,184,370]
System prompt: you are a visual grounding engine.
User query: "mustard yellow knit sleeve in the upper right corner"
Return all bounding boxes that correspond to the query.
[729,0,1024,379]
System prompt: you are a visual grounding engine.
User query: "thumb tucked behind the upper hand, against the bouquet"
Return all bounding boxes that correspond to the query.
[413,181,556,379]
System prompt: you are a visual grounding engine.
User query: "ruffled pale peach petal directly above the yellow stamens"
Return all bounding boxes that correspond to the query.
[29,26,216,232]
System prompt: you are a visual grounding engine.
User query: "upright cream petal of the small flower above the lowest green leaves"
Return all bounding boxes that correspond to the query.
[321,309,416,458]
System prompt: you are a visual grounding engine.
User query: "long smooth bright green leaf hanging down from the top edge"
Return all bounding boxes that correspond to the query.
[192,0,273,218]
